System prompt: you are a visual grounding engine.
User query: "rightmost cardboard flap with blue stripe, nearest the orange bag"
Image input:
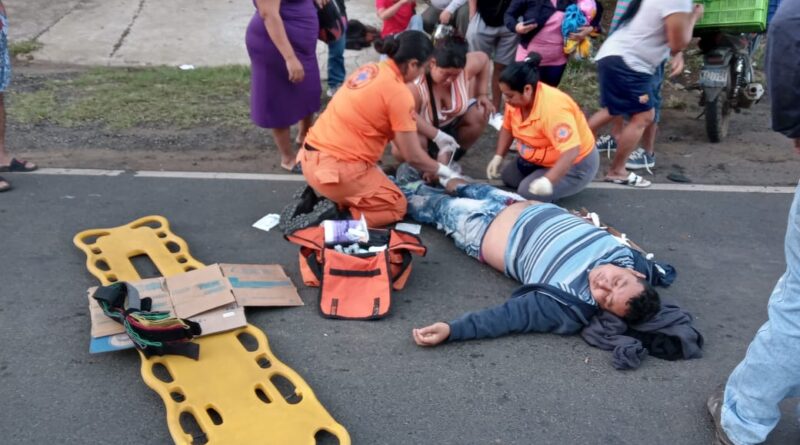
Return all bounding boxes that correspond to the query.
[219,264,303,307]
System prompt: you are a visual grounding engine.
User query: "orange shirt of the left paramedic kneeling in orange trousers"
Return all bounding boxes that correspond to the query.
[306,60,417,163]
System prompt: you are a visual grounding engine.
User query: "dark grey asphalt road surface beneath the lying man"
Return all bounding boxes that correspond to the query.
[0,174,800,445]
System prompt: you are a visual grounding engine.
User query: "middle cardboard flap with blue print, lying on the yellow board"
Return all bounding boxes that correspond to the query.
[165,264,236,318]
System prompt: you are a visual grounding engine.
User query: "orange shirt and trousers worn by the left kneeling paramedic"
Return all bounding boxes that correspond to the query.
[297,60,417,227]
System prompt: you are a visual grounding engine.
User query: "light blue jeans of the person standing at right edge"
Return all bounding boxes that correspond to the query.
[722,182,800,445]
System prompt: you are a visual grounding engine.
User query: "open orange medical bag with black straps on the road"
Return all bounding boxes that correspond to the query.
[286,226,427,320]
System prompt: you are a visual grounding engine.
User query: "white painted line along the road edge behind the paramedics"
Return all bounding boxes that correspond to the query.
[31,168,795,194]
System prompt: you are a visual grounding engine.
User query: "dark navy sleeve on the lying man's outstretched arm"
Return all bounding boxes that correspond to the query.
[449,292,583,341]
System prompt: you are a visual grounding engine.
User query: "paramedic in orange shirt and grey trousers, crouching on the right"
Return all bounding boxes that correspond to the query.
[486,52,600,202]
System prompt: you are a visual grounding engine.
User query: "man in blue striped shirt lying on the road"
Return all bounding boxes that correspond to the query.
[396,164,703,369]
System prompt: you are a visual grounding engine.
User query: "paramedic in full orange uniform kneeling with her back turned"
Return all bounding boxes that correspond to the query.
[297,31,453,227]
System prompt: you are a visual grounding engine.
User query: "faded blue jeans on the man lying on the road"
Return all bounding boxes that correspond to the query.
[400,182,525,260]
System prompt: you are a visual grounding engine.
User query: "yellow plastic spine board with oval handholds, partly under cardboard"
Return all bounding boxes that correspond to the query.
[73,216,350,445]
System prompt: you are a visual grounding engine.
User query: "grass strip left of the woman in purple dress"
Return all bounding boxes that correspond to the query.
[8,66,251,130]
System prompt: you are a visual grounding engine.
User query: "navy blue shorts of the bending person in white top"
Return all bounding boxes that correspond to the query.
[597,56,660,116]
